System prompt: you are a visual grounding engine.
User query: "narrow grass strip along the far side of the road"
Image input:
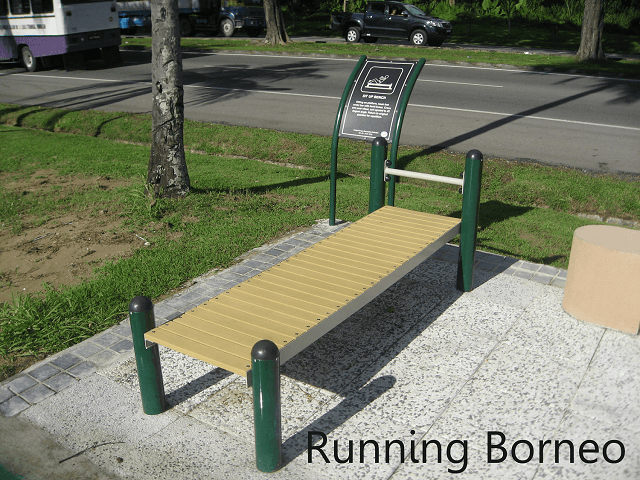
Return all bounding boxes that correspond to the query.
[122,37,640,77]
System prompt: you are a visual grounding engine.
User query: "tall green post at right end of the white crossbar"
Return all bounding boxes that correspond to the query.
[456,150,482,292]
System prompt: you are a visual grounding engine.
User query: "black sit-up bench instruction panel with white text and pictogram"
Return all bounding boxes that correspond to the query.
[340,60,416,143]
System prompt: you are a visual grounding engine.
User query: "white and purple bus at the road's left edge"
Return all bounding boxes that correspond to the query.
[0,0,120,72]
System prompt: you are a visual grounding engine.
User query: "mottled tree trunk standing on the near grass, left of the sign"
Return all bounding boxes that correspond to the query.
[147,0,191,198]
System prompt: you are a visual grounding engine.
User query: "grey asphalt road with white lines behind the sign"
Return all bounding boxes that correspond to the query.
[0,51,640,174]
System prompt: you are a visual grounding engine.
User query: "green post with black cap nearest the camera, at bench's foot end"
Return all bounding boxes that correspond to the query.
[251,340,282,472]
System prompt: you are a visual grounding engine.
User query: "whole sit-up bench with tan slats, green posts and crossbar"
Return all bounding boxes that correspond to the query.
[129,142,482,472]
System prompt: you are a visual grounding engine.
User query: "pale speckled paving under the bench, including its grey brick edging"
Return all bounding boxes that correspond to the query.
[0,219,640,480]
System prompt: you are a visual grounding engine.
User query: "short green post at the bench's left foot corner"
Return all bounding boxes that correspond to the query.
[129,296,165,415]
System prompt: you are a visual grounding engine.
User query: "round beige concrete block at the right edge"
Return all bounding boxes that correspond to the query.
[562,225,640,335]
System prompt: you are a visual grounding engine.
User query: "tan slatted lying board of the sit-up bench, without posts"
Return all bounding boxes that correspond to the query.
[145,206,460,377]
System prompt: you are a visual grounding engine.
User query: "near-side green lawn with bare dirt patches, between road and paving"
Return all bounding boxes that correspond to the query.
[0,105,640,368]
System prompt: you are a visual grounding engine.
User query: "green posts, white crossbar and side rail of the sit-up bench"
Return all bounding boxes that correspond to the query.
[129,138,483,472]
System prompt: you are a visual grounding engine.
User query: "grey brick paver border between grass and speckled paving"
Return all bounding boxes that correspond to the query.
[0,220,567,417]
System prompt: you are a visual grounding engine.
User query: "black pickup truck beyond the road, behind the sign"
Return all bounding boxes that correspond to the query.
[331,1,452,47]
